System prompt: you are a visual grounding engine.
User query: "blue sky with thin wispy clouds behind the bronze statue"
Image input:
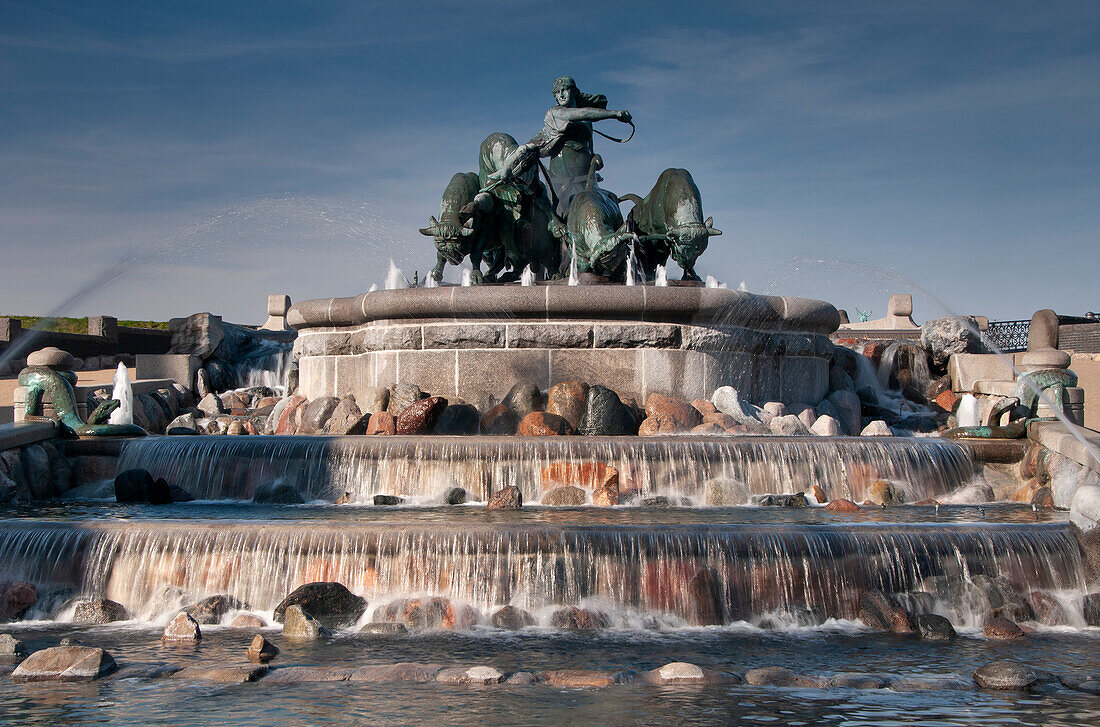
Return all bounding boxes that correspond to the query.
[0,0,1100,322]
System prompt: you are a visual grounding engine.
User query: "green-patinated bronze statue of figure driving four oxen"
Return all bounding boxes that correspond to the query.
[420,76,722,284]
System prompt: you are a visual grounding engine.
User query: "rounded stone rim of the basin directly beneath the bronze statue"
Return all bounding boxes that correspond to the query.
[287,285,840,334]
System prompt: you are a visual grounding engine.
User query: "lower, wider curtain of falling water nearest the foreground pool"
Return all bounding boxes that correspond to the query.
[0,520,1085,626]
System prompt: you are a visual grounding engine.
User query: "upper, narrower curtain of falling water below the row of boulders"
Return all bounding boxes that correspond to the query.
[119,436,974,506]
